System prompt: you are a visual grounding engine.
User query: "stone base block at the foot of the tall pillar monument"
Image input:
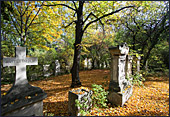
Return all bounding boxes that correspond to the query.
[107,85,132,106]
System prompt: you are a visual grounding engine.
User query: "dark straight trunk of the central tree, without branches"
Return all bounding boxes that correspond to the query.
[71,1,83,87]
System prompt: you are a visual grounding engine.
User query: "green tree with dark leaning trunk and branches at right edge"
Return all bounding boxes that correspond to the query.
[113,1,169,69]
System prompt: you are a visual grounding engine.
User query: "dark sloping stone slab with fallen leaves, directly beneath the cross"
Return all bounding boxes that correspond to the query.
[1,84,47,115]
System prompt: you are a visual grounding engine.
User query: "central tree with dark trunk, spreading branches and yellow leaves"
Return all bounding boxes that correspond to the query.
[44,1,134,87]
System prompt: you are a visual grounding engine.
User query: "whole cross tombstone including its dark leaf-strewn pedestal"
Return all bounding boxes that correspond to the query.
[1,47,47,116]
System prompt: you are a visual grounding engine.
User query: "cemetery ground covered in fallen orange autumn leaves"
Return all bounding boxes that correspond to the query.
[1,70,169,116]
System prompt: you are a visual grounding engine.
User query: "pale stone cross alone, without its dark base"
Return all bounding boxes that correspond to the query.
[3,47,38,85]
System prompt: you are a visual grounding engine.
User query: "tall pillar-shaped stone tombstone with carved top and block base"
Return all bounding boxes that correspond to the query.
[108,43,132,106]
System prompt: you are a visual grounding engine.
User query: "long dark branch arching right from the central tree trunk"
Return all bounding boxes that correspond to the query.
[83,6,135,32]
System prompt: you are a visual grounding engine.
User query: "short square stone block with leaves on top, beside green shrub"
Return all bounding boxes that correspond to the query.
[68,89,92,116]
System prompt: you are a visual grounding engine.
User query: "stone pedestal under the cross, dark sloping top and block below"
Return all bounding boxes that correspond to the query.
[1,84,47,116]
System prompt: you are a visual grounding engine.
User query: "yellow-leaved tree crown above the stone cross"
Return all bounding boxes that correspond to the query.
[2,1,62,49]
